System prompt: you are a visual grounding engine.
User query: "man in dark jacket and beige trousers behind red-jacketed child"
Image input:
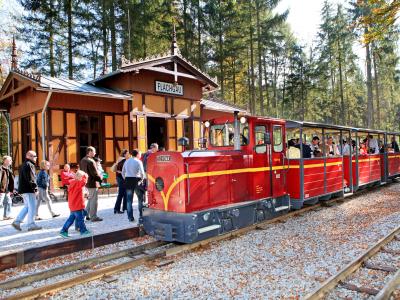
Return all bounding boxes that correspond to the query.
[80,146,103,222]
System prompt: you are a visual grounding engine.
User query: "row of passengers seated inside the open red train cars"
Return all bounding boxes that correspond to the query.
[286,135,400,159]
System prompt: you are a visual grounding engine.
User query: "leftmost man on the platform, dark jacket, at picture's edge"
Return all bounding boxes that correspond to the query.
[0,156,14,220]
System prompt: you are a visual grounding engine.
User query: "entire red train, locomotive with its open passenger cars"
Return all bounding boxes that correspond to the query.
[142,112,400,243]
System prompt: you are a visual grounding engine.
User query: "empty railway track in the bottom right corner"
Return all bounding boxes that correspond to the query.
[305,226,400,300]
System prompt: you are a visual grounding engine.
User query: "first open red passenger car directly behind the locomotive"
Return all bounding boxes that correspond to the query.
[286,121,351,209]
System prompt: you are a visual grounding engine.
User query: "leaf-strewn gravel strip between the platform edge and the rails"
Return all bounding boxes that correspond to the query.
[0,236,155,288]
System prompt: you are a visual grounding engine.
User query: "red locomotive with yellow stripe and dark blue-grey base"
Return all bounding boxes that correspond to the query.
[143,115,290,243]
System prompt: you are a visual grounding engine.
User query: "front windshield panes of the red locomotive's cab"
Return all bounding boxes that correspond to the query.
[210,123,249,147]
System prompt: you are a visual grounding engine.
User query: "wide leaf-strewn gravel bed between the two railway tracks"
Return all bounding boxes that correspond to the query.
[46,184,400,299]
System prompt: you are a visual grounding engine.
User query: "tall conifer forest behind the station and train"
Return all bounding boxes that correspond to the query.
[0,0,400,153]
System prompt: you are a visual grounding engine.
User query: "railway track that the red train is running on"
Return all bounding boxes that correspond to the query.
[0,184,396,300]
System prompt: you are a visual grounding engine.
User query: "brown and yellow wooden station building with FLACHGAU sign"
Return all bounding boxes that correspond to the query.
[0,35,245,185]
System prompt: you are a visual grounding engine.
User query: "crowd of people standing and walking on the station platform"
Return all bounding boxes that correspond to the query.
[0,143,159,238]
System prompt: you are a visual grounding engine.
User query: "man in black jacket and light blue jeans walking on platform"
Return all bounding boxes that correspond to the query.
[11,150,42,231]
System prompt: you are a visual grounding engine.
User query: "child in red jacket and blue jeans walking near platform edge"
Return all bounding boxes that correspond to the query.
[60,171,92,238]
